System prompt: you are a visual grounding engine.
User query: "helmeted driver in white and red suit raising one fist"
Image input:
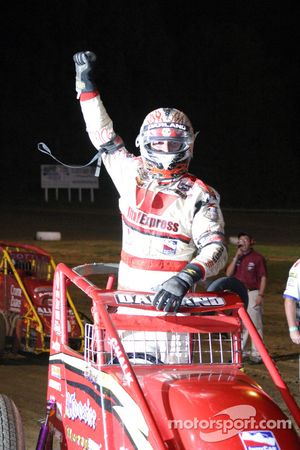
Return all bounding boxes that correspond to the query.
[73,51,227,362]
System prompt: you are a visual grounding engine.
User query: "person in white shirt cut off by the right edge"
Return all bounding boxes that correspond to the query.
[283,259,300,344]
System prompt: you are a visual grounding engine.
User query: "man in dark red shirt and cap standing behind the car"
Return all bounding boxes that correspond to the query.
[226,232,267,364]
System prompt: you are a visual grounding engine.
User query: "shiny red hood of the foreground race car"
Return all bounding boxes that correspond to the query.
[134,366,299,450]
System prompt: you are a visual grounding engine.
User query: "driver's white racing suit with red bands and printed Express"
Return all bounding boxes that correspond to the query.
[80,92,227,362]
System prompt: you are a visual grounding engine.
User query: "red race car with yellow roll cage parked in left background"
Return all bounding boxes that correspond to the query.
[0,241,84,355]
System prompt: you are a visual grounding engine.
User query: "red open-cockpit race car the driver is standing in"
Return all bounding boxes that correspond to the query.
[36,263,300,450]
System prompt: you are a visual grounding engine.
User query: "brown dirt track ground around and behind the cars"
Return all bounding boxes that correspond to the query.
[0,205,300,450]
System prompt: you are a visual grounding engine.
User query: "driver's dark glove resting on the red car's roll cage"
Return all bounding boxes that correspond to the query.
[153,264,203,312]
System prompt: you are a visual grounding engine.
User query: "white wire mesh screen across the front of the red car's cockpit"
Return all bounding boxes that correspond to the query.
[84,324,240,365]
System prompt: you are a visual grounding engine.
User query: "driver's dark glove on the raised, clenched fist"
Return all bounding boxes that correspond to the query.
[73,51,97,98]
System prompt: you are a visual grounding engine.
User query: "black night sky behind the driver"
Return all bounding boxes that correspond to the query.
[0,0,300,209]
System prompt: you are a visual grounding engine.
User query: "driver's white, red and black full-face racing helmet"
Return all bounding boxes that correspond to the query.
[135,108,195,179]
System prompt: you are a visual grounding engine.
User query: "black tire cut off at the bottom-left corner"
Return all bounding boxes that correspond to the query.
[0,394,25,450]
